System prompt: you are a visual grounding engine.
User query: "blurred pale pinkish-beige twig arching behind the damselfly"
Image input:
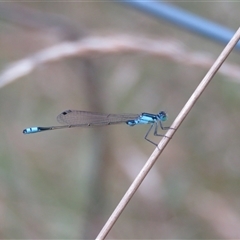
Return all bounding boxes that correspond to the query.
[0,35,240,87]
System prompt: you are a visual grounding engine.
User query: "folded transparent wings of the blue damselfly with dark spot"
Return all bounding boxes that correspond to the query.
[57,110,139,127]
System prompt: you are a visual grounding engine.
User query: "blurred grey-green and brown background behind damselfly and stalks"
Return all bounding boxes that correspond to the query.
[0,1,240,239]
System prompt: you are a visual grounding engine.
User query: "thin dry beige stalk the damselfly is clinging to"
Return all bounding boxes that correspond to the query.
[96,28,240,239]
